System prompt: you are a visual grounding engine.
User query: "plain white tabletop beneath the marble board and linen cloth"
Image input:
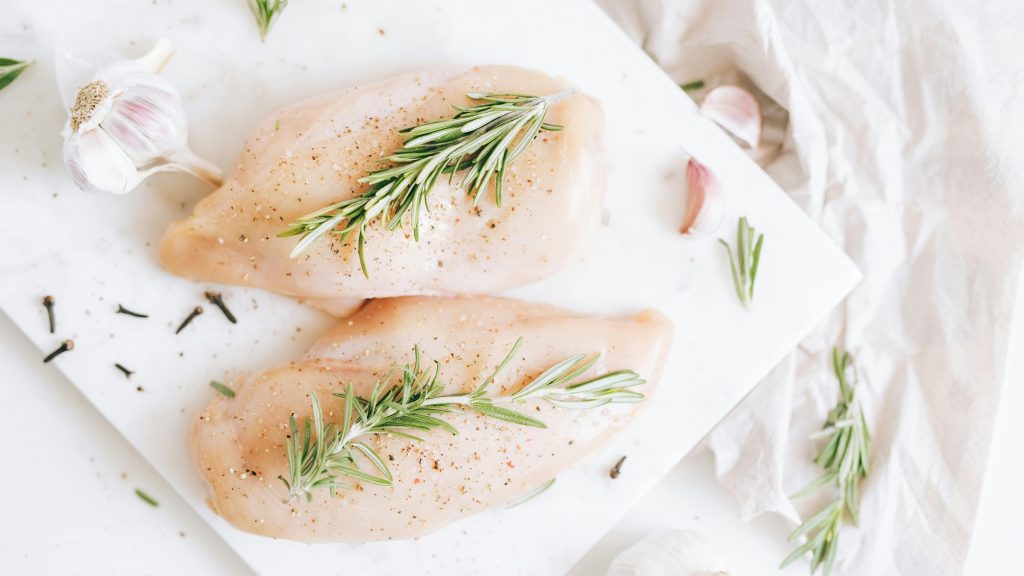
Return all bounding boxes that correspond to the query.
[0,280,1024,576]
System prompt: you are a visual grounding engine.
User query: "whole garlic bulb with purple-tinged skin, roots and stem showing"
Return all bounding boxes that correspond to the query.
[62,40,221,194]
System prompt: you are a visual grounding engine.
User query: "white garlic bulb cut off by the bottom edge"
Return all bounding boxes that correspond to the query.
[607,530,739,576]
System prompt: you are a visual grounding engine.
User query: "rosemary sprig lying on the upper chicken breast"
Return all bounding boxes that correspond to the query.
[278,90,573,278]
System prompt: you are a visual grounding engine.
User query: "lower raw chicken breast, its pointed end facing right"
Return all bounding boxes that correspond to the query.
[190,297,672,542]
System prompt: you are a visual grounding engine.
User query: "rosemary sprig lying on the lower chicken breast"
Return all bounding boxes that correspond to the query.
[279,338,644,502]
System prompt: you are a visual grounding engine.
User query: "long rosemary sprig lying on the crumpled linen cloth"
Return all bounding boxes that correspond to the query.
[779,348,870,576]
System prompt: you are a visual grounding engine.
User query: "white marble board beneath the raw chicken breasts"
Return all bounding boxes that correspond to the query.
[0,0,858,574]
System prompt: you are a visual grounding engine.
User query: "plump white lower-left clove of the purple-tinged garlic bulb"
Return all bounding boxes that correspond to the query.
[63,128,141,195]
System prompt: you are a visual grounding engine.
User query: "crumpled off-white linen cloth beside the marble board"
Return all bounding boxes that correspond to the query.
[598,0,1024,576]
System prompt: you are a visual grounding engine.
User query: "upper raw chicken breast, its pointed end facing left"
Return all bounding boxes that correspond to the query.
[160,66,605,312]
